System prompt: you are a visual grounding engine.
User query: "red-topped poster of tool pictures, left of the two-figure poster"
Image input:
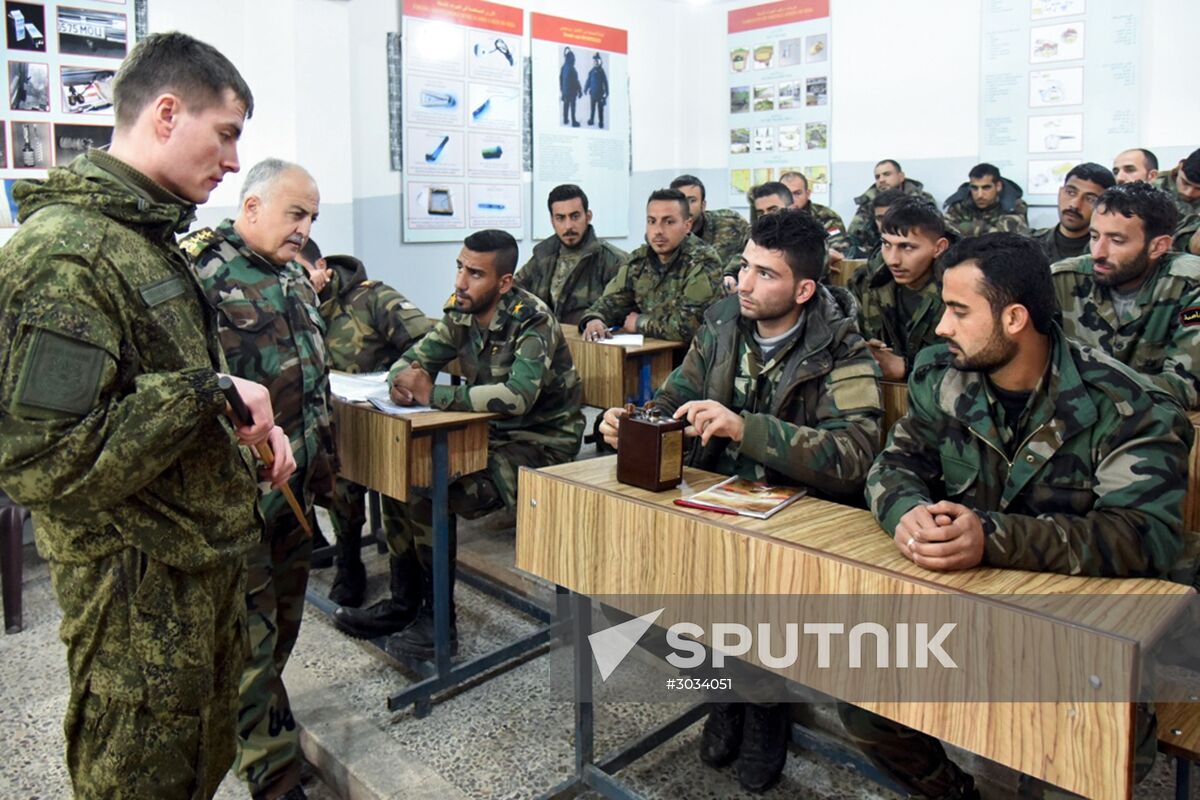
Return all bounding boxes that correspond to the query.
[401,0,527,242]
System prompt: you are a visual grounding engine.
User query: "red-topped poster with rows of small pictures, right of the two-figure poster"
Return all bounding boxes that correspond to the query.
[724,0,833,207]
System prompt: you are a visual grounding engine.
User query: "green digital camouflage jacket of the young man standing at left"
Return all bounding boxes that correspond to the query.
[0,150,262,572]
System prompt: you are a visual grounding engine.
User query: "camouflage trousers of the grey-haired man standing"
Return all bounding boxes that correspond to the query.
[234,482,312,800]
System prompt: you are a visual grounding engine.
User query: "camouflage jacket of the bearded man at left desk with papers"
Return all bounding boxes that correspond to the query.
[389,287,583,461]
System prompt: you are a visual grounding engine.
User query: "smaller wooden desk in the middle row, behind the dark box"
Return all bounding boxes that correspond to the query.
[563,325,683,408]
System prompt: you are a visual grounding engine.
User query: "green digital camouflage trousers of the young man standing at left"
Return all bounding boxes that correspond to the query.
[49,551,246,800]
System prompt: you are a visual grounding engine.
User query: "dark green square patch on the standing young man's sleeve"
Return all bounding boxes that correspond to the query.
[17,329,107,416]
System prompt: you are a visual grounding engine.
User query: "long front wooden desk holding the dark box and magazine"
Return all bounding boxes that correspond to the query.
[516,456,1190,798]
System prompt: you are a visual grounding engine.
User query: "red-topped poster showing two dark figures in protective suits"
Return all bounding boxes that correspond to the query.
[530,13,629,239]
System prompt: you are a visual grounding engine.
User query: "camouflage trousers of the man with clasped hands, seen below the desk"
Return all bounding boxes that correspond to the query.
[838,703,1158,800]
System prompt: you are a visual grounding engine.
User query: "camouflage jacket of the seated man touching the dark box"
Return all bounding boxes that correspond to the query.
[654,287,883,499]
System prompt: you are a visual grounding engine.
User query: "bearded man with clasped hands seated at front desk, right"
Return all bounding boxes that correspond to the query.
[839,233,1194,798]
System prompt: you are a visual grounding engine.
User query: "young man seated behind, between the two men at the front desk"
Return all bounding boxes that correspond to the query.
[858,197,953,380]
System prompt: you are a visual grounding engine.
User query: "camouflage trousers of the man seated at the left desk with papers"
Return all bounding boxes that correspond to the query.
[384,440,570,572]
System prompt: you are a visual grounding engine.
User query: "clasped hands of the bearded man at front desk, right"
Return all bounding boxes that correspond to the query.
[893,500,984,572]
